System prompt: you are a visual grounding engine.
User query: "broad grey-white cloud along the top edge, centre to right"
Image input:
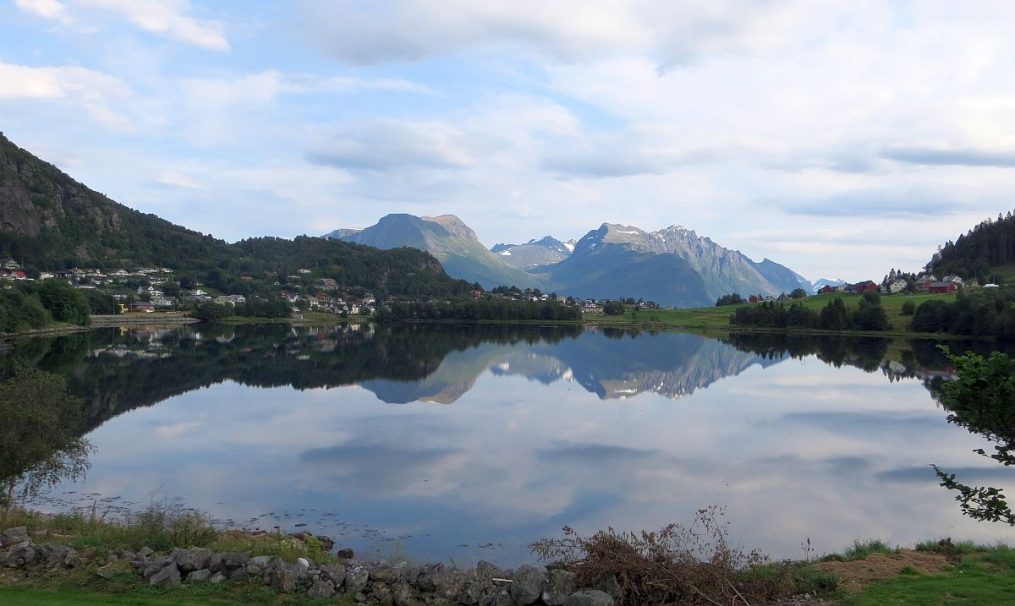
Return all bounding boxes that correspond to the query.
[299,0,799,65]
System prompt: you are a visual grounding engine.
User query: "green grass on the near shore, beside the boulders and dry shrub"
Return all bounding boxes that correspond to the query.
[0,506,1015,606]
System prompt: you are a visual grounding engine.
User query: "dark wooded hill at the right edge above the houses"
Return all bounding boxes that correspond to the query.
[929,211,1015,281]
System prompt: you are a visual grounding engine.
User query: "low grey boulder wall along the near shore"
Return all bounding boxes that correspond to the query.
[0,527,618,606]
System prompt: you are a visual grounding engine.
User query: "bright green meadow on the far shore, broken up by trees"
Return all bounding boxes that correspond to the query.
[585,292,955,334]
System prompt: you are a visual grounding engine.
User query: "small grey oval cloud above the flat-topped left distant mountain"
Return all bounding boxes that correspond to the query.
[307,120,474,173]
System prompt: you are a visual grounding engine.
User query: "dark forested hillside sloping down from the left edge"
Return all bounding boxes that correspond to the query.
[0,134,472,295]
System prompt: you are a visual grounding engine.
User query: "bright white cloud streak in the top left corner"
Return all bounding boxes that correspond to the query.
[16,0,229,51]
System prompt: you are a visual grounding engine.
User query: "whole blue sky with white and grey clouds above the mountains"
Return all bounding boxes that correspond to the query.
[0,0,1015,280]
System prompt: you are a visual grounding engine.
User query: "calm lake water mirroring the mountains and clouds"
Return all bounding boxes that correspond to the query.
[2,326,1015,565]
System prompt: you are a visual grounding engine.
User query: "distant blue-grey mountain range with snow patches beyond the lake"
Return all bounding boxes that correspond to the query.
[325,214,814,307]
